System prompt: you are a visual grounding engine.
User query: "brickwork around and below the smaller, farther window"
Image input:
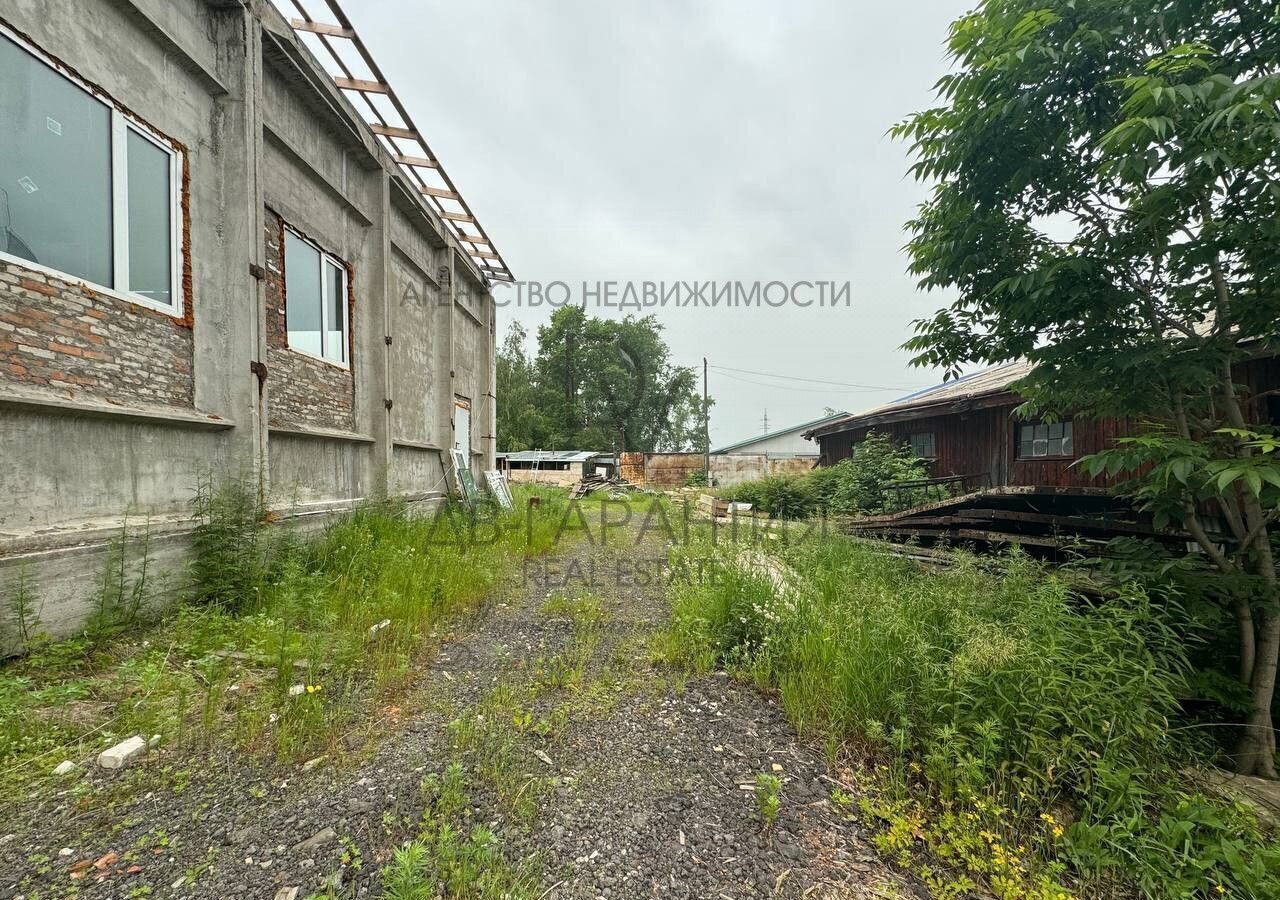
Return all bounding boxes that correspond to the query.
[264,210,356,431]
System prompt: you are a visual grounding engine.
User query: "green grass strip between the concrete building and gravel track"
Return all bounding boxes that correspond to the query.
[0,492,566,783]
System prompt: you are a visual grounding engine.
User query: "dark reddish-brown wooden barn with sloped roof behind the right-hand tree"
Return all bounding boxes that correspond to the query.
[805,353,1280,547]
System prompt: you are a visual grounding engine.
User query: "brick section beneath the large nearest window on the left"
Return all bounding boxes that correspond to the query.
[0,264,195,408]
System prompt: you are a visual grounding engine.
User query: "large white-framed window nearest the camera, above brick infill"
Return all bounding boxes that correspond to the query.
[0,29,182,315]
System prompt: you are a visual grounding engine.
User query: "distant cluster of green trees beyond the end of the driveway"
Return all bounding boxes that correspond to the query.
[498,306,704,452]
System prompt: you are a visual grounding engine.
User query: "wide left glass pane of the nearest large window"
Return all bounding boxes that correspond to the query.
[0,37,113,287]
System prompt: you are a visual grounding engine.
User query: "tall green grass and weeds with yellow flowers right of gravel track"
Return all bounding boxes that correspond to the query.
[658,538,1280,900]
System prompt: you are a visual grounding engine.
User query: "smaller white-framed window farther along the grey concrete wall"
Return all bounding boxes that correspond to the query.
[284,228,349,366]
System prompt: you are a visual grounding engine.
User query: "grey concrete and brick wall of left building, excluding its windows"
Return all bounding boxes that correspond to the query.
[0,0,494,645]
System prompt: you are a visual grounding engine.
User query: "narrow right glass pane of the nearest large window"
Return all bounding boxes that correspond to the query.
[127,128,173,306]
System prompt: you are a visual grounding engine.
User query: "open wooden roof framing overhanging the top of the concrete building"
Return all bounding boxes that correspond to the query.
[274,0,515,282]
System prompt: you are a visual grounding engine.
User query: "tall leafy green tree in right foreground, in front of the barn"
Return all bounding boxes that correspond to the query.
[893,0,1280,776]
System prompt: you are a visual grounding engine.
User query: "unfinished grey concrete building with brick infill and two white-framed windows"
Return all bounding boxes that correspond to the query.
[0,0,509,634]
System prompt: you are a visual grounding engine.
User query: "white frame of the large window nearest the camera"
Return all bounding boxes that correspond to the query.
[0,24,186,319]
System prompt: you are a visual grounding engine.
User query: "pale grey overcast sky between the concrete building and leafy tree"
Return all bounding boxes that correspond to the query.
[346,0,972,447]
